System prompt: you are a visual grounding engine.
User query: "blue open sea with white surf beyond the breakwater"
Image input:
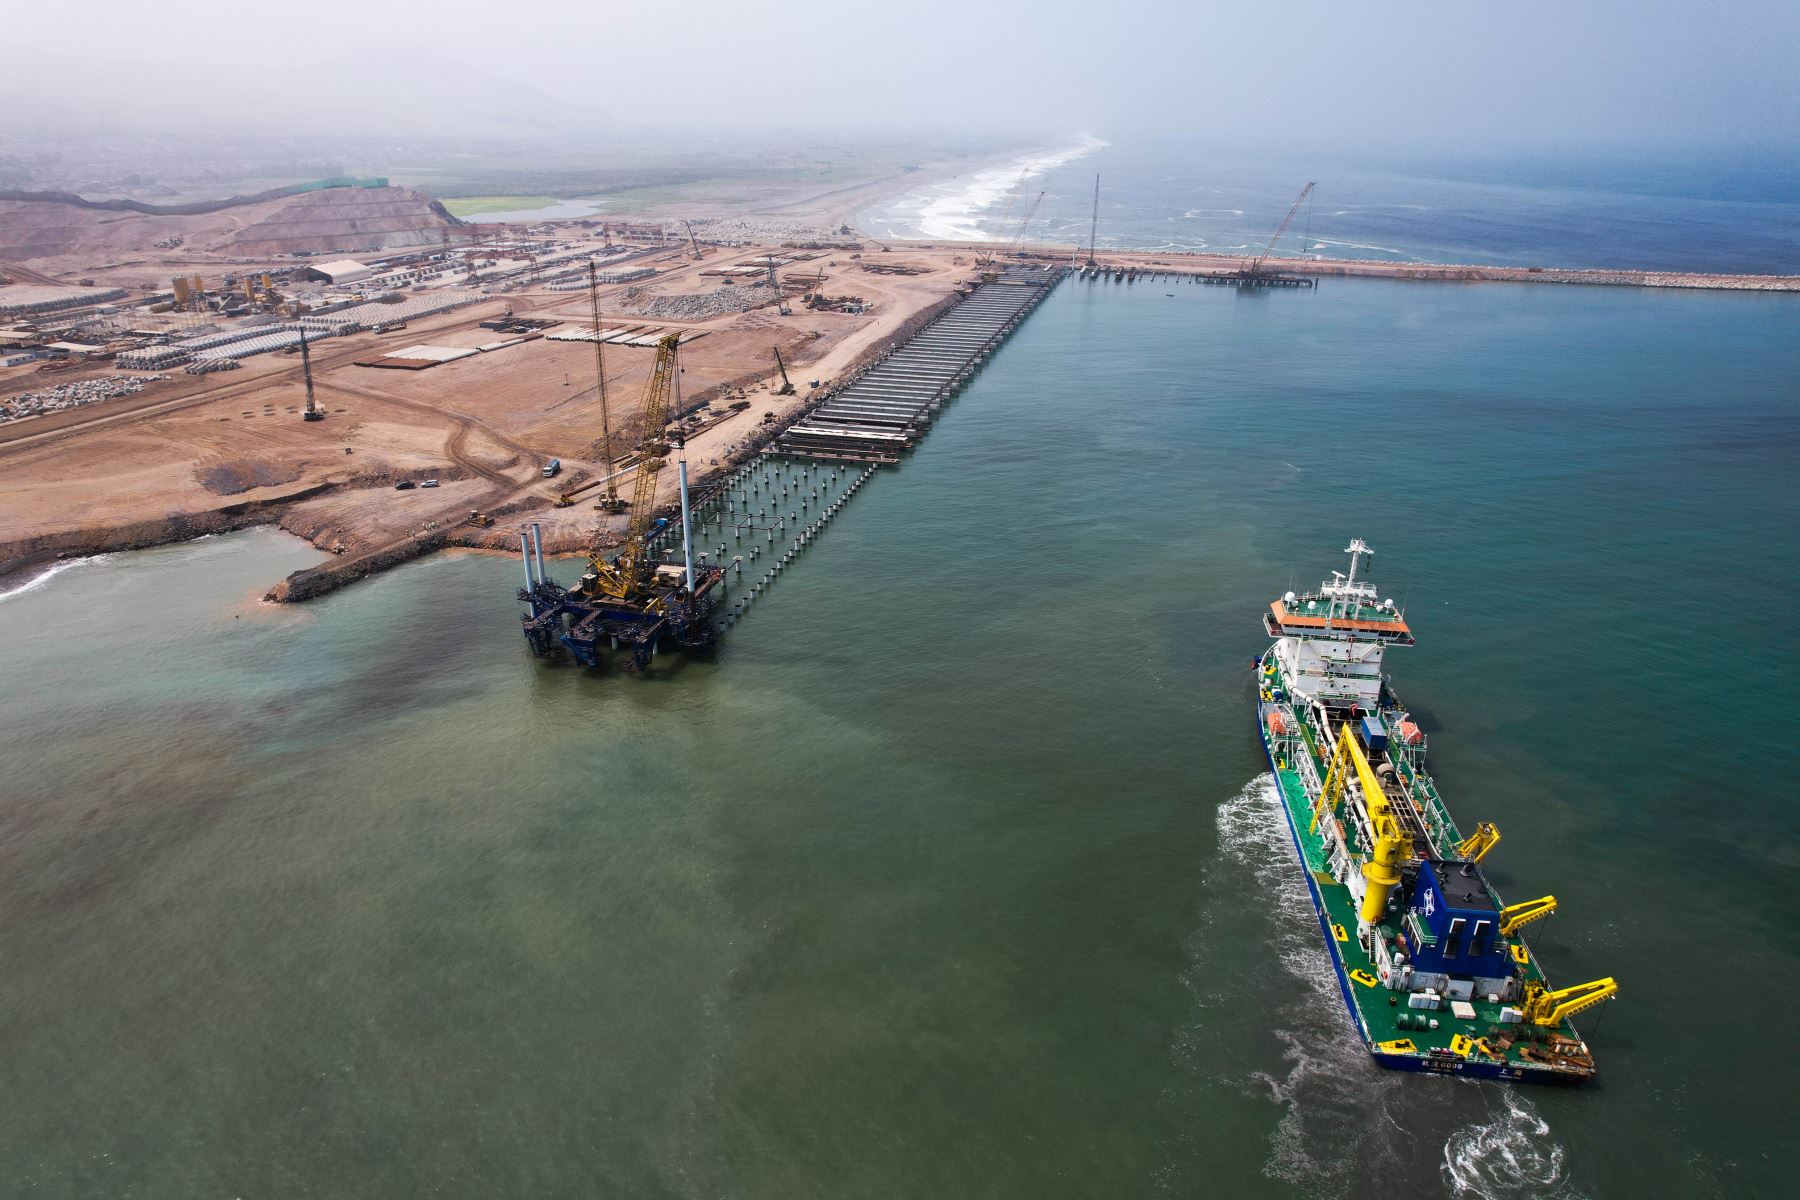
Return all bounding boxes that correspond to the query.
[860,137,1800,273]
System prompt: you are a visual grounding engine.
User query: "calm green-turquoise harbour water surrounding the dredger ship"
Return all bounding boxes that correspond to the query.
[0,281,1800,1196]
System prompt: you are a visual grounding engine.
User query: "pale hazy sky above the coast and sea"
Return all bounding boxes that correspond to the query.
[14,0,1800,153]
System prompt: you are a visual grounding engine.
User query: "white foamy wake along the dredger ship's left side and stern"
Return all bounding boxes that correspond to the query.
[1215,775,1579,1200]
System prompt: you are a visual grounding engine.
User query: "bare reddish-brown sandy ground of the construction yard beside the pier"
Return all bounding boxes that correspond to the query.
[0,248,974,575]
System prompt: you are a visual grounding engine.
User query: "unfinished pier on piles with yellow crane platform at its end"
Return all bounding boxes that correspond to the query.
[518,266,1066,673]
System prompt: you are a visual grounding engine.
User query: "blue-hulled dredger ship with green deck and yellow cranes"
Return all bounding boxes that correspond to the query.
[1255,540,1618,1083]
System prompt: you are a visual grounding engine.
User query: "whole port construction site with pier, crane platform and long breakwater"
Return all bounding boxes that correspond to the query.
[0,170,1800,669]
